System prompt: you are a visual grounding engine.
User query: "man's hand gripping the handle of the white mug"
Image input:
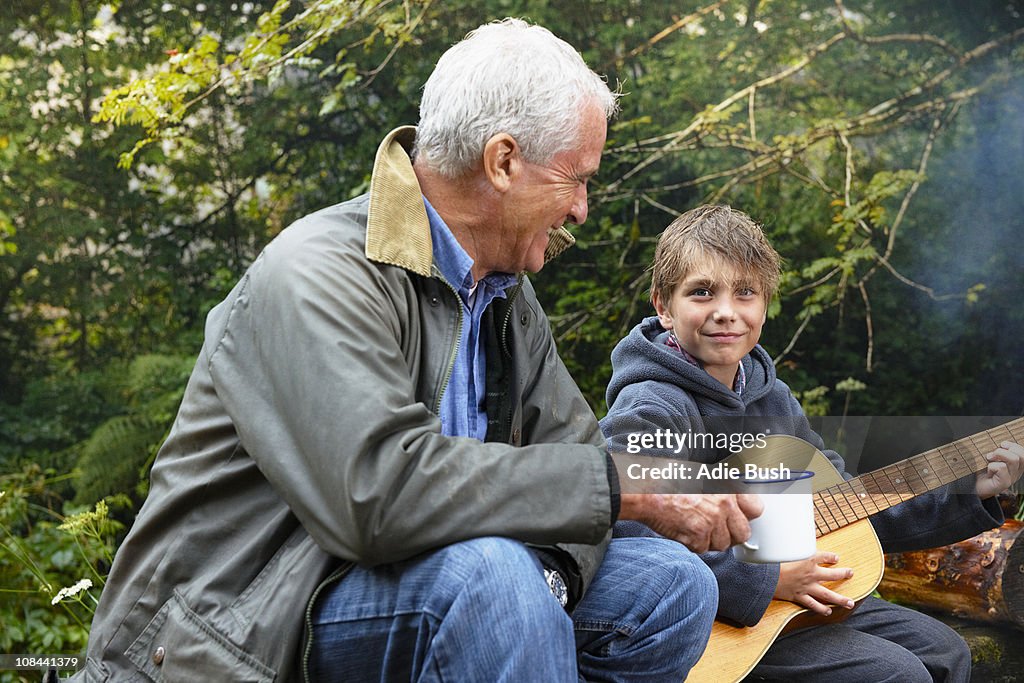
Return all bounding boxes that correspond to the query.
[618,494,764,553]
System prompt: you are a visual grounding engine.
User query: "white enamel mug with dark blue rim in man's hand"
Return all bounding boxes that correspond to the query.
[732,470,817,563]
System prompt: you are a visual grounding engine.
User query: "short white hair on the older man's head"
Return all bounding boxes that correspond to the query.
[416,18,618,178]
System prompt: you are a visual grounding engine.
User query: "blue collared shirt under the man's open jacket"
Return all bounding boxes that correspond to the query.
[423,198,517,441]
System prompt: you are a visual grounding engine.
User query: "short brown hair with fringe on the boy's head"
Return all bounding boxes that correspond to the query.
[651,205,781,303]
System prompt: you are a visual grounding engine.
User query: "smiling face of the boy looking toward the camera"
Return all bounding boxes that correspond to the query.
[653,259,766,388]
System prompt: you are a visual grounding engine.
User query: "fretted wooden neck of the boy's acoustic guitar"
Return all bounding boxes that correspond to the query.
[814,418,1024,537]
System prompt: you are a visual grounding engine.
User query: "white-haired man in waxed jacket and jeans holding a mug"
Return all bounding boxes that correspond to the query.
[75,19,760,681]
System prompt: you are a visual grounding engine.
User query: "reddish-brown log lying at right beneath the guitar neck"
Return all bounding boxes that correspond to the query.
[878,519,1024,630]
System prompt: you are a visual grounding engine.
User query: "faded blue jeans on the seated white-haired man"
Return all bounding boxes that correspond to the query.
[309,538,718,683]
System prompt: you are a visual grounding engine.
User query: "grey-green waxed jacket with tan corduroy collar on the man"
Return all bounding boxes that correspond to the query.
[74,127,611,682]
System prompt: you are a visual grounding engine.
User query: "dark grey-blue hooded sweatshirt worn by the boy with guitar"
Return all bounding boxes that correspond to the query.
[601,316,1002,626]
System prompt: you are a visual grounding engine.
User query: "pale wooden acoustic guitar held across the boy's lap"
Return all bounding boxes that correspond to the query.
[686,418,1024,683]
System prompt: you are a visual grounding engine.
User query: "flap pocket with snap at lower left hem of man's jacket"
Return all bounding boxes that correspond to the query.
[125,593,275,683]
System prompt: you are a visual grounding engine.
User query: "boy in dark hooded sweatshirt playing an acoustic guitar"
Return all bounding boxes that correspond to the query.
[601,206,1024,683]
